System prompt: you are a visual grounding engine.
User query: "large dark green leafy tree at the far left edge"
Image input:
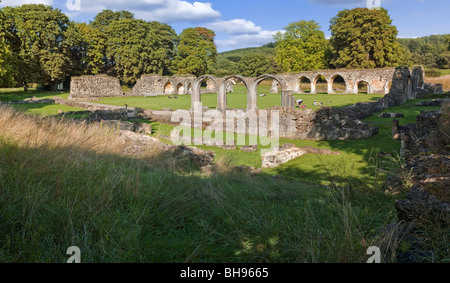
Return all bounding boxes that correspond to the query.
[2,4,69,89]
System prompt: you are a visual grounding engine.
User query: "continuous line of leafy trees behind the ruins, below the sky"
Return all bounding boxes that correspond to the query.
[0,4,450,89]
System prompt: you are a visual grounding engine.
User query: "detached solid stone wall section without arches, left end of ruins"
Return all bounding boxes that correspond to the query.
[69,75,123,99]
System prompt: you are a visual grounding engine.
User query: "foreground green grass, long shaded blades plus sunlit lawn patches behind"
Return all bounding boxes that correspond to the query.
[0,95,444,263]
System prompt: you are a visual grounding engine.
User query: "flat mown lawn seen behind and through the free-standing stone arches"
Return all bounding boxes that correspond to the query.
[97,85,384,110]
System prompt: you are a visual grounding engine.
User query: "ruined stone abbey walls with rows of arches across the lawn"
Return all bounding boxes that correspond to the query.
[71,67,443,140]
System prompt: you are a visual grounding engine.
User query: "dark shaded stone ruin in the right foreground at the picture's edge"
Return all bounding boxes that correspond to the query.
[379,101,450,263]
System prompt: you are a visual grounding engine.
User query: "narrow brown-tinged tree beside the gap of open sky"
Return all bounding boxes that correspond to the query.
[174,27,217,76]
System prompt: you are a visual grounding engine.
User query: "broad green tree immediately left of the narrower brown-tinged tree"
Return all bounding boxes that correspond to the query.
[105,19,177,84]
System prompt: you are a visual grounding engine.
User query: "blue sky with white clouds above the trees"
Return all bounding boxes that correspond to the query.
[0,0,450,52]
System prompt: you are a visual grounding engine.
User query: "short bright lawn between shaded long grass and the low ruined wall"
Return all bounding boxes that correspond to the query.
[145,100,439,186]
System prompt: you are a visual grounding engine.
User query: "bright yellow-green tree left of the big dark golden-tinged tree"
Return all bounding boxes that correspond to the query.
[274,21,327,72]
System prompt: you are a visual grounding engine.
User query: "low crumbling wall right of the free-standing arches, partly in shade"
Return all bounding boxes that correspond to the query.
[165,67,442,141]
